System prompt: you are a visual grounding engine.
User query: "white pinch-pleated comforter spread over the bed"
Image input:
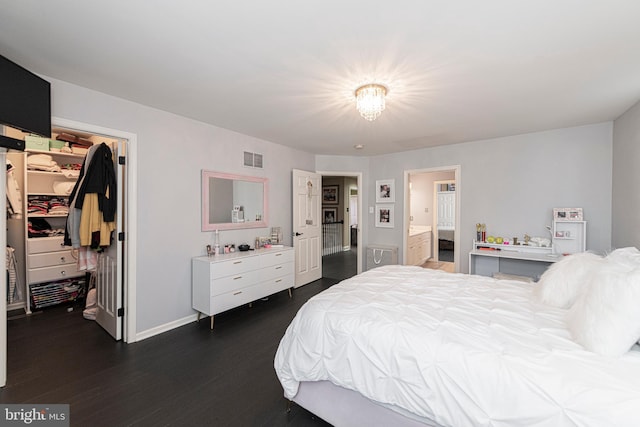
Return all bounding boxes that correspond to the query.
[275,266,640,427]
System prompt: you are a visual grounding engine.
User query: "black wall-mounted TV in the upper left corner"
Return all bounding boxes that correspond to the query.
[0,55,51,148]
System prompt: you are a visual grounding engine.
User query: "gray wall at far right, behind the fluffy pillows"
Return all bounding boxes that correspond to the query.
[611,102,640,248]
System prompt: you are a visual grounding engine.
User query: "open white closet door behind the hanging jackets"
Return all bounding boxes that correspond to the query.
[96,140,126,340]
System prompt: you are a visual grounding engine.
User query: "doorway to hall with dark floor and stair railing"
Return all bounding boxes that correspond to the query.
[319,172,362,281]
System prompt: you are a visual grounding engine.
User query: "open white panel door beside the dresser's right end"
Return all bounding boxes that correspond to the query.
[292,169,322,288]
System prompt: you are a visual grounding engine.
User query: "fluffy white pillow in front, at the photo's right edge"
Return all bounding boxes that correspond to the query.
[567,264,640,356]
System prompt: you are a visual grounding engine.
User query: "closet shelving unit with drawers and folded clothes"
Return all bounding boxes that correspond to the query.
[7,149,85,314]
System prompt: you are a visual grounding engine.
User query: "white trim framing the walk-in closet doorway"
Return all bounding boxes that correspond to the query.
[0,117,137,386]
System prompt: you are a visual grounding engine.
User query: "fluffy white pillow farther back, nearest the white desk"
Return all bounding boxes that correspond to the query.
[533,252,605,308]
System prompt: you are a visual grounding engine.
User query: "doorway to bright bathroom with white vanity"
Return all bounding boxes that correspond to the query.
[403,166,460,272]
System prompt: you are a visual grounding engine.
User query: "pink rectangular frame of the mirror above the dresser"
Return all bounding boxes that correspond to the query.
[202,170,269,231]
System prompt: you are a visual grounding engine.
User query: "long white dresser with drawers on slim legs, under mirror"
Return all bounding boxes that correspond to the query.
[191,247,294,329]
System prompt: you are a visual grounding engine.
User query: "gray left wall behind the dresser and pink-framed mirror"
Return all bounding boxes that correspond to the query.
[47,78,315,333]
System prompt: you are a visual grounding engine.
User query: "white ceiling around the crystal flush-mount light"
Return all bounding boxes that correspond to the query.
[0,0,640,155]
